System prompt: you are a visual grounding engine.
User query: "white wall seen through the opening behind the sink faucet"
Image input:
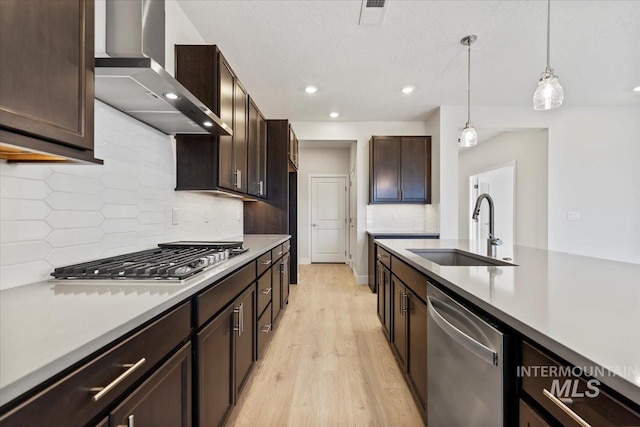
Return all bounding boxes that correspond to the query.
[458,130,549,249]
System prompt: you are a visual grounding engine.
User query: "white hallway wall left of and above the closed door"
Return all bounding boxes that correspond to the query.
[296,147,350,264]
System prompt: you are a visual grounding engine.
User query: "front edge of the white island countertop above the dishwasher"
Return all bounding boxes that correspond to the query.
[379,239,640,405]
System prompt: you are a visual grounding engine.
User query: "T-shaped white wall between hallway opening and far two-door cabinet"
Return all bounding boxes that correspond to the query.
[293,122,428,284]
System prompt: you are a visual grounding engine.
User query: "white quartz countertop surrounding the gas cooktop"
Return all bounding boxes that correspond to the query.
[0,235,290,406]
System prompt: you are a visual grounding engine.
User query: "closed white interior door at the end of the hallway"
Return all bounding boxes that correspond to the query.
[311,176,347,263]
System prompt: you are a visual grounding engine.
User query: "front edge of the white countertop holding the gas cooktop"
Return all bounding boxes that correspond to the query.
[0,234,291,409]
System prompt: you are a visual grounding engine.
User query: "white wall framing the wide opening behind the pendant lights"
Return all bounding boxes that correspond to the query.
[440,106,640,263]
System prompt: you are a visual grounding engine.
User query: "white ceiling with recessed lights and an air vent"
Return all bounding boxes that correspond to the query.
[180,0,640,121]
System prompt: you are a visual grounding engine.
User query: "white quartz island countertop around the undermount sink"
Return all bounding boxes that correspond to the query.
[376,239,640,405]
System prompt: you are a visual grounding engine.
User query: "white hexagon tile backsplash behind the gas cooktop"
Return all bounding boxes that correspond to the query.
[0,101,243,289]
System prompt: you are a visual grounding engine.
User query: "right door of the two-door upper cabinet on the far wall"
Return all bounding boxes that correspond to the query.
[400,137,431,203]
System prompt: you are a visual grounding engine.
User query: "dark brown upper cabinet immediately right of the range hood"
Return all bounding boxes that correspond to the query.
[176,45,252,194]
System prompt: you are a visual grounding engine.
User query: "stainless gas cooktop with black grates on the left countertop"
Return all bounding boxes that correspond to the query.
[51,241,247,281]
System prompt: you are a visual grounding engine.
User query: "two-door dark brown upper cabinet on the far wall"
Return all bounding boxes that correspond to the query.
[369,136,431,203]
